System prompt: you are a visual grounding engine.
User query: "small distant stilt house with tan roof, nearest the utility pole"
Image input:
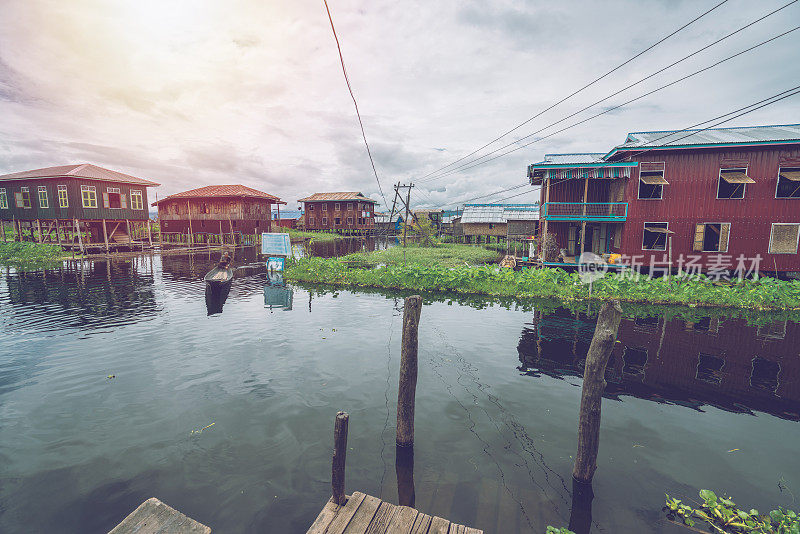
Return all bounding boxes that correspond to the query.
[298,192,376,233]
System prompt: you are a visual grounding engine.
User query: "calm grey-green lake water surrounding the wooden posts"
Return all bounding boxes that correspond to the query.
[0,252,800,533]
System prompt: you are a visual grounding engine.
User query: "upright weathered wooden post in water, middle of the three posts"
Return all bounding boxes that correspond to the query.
[397,295,422,447]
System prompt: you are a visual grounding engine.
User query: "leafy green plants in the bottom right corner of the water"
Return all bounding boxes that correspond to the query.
[664,490,800,534]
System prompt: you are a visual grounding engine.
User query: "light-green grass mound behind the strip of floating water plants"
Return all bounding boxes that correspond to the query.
[341,244,498,268]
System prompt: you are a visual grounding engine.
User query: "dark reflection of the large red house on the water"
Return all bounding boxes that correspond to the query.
[518,310,800,420]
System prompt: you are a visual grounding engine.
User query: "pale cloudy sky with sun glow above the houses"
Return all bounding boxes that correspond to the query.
[0,0,800,214]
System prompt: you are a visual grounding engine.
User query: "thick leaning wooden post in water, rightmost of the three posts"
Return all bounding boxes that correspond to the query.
[572,300,622,483]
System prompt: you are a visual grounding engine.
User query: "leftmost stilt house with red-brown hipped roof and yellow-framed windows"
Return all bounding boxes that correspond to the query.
[0,163,159,248]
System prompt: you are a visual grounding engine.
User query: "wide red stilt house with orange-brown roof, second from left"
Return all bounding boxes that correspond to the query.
[153,184,286,239]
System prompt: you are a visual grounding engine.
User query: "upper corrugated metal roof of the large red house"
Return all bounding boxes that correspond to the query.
[612,124,800,152]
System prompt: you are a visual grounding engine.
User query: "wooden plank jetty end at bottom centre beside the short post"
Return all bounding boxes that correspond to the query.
[306,491,483,534]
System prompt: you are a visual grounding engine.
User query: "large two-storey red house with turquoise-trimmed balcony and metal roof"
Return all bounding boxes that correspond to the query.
[528,124,800,272]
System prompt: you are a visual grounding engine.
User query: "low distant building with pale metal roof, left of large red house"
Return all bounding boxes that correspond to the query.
[458,204,539,241]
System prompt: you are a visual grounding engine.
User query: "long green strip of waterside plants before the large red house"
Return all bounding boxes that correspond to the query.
[286,258,800,311]
